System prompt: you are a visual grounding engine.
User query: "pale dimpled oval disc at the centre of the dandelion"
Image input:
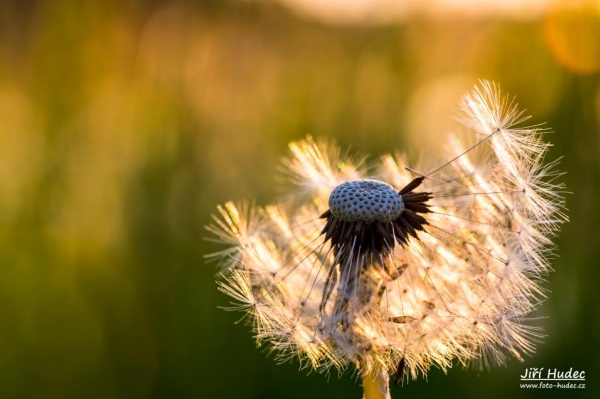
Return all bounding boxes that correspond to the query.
[329,179,404,223]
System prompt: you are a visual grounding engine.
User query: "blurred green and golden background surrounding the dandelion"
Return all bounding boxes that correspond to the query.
[0,0,600,399]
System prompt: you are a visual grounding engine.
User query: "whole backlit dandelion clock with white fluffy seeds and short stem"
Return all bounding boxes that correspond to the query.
[208,81,566,397]
